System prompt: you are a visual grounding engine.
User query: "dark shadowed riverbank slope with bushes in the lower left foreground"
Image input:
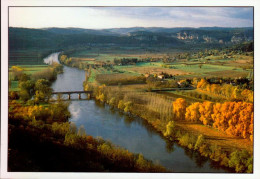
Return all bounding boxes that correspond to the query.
[8,110,167,172]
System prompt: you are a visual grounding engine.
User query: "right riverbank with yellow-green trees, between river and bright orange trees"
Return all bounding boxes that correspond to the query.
[88,84,252,173]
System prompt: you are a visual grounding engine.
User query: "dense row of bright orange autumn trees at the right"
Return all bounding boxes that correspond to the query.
[173,98,254,140]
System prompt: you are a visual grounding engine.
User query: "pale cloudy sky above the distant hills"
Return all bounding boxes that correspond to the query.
[9,7,253,29]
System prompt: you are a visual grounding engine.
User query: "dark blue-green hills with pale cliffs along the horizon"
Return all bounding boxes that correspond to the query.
[9,27,253,50]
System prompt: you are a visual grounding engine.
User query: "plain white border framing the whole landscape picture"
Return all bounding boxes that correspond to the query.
[0,0,260,179]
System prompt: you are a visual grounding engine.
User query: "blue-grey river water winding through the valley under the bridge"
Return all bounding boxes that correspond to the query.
[45,53,227,173]
